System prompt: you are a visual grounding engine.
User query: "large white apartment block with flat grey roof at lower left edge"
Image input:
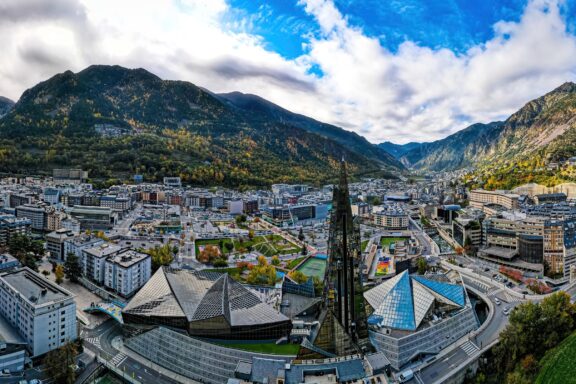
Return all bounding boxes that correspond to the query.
[0,267,77,357]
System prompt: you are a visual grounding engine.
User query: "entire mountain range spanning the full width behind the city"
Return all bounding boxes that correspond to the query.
[0,65,576,188]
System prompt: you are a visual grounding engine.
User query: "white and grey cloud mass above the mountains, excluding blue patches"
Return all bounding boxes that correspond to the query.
[0,0,576,142]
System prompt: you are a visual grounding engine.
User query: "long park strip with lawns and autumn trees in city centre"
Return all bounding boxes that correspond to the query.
[196,235,301,257]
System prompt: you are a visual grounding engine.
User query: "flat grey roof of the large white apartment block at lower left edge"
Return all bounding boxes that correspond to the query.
[0,267,74,306]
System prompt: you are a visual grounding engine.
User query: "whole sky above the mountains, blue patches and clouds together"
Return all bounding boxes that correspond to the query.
[0,0,576,143]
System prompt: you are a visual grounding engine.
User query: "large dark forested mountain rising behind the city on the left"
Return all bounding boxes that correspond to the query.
[0,65,403,187]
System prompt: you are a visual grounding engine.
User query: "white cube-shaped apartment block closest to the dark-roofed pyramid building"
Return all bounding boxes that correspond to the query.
[104,250,152,297]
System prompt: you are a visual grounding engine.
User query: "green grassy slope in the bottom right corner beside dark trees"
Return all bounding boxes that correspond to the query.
[536,332,576,384]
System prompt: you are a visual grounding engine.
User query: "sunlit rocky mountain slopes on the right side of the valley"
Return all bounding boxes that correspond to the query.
[379,82,576,187]
